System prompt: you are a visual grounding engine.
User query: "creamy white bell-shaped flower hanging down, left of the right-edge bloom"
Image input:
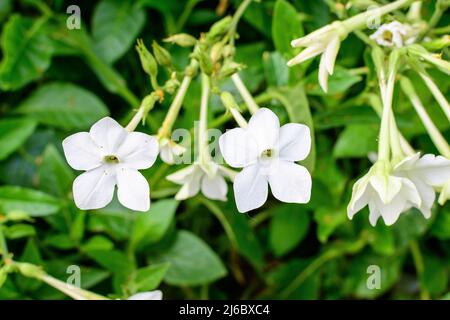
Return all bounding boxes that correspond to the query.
[347,161,422,226]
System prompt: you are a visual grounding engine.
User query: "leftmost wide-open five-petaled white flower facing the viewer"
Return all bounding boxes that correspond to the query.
[62,117,158,211]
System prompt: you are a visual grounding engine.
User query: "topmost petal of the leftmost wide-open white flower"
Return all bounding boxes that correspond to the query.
[89,117,128,155]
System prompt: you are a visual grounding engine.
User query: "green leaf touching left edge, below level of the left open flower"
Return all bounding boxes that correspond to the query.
[0,186,61,217]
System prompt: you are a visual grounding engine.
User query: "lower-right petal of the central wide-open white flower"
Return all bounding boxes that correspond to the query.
[269,161,312,203]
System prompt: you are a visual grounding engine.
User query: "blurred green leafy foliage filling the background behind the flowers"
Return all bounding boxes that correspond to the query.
[0,0,450,299]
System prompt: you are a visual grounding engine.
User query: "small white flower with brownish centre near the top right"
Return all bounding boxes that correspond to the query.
[370,21,409,48]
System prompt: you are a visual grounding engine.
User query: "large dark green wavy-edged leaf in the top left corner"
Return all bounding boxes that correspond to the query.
[0,14,53,90]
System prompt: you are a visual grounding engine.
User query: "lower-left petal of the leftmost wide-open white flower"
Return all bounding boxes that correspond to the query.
[72,166,116,210]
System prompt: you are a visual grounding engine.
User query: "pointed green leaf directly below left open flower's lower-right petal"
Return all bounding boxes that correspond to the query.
[130,199,178,248]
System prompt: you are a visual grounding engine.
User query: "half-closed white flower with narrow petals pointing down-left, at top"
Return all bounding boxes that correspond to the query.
[287,21,348,92]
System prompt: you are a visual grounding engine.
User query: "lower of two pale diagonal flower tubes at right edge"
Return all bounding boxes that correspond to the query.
[400,77,450,158]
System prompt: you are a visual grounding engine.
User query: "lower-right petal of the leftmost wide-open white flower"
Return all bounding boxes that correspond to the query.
[117,166,150,212]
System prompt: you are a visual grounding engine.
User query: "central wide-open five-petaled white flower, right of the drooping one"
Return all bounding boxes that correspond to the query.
[219,108,311,212]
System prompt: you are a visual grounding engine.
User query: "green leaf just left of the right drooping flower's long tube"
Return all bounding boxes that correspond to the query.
[333,124,378,158]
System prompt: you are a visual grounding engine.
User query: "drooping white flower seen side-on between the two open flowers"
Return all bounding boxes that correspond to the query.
[166,161,233,201]
